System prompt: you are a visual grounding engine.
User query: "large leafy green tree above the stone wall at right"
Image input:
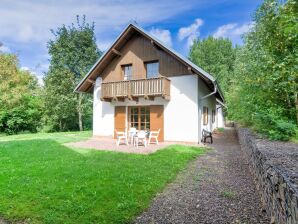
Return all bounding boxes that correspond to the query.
[228,0,298,140]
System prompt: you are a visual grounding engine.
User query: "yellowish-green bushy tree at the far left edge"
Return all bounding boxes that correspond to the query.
[0,53,42,134]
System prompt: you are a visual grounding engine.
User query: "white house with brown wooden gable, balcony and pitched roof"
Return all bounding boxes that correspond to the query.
[75,24,224,142]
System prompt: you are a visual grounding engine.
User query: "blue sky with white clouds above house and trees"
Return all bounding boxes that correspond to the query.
[0,0,261,83]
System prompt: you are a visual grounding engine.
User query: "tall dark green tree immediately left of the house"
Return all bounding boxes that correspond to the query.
[44,16,101,131]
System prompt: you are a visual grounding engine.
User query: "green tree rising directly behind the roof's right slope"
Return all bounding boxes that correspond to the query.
[189,36,236,94]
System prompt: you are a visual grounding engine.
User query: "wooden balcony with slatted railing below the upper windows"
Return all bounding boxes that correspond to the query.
[101,77,171,102]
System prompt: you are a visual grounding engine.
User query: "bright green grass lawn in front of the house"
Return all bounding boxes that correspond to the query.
[0,132,204,223]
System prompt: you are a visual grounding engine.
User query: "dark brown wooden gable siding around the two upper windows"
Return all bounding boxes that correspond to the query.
[101,35,189,82]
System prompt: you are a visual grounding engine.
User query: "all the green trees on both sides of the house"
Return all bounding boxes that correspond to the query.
[0,0,298,141]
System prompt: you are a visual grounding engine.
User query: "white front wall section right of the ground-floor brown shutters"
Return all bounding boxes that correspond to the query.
[164,75,199,142]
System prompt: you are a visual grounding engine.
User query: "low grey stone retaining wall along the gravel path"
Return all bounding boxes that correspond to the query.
[237,127,298,224]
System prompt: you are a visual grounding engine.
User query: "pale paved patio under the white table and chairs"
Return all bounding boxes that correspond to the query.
[65,137,203,154]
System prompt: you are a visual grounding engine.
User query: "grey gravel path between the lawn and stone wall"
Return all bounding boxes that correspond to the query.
[136,129,270,224]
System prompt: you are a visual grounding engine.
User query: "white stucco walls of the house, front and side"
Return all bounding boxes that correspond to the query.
[93,75,217,142]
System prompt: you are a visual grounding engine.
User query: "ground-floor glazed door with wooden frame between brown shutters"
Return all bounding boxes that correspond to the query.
[128,106,150,130]
